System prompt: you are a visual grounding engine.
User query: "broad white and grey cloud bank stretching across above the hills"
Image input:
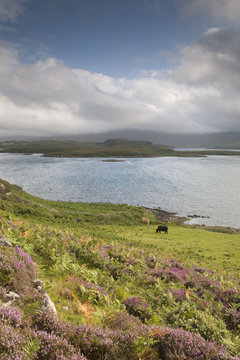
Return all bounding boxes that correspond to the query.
[0,29,240,134]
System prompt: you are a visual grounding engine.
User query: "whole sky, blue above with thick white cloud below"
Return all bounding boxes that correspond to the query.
[0,0,240,138]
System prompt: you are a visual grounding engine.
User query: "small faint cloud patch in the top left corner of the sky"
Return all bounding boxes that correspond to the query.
[0,0,28,22]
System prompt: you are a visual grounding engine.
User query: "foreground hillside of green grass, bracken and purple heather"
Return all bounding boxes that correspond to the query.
[0,180,240,360]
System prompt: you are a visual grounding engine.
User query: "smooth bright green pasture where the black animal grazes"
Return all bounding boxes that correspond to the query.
[98,225,240,273]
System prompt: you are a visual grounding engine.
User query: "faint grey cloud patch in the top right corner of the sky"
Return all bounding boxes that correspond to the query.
[177,0,240,21]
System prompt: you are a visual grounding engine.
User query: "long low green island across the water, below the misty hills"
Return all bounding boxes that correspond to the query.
[0,139,240,161]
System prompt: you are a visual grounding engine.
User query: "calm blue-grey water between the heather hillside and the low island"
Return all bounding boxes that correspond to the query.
[0,154,240,228]
